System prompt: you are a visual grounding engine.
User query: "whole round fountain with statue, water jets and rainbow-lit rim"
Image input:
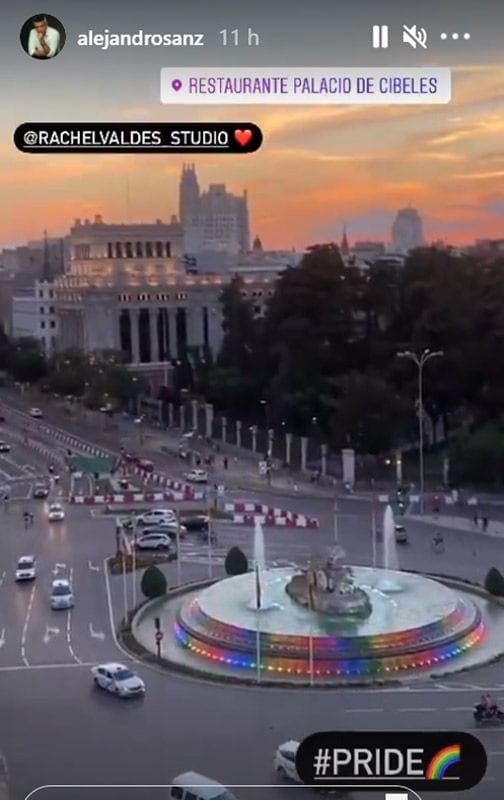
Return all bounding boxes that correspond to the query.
[137,507,504,684]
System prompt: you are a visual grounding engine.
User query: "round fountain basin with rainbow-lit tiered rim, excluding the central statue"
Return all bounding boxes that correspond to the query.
[175,567,485,680]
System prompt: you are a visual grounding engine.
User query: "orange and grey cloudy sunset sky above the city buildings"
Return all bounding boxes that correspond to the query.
[0,3,504,248]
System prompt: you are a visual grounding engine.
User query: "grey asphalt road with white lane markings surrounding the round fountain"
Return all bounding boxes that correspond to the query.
[0,406,504,800]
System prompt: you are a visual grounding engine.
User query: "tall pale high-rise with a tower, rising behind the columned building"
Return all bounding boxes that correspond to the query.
[179,164,250,255]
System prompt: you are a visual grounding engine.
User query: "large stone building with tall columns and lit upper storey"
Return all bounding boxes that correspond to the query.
[54,216,273,372]
